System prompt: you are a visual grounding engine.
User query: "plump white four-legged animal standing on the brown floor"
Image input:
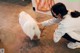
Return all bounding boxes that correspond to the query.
[19,11,41,40]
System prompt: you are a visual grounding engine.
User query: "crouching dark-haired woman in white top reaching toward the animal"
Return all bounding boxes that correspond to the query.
[38,3,80,49]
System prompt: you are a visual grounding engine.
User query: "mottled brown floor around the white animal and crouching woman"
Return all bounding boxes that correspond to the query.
[0,1,80,53]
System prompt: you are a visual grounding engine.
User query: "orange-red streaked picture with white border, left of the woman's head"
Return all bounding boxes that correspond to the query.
[32,0,54,15]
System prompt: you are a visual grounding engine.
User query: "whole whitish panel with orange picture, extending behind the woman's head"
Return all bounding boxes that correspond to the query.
[32,0,80,15]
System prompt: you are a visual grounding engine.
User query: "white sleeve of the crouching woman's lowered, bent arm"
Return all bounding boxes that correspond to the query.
[53,24,66,43]
